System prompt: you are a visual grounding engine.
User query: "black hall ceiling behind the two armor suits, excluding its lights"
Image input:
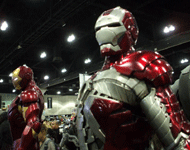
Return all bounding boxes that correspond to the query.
[0,0,190,95]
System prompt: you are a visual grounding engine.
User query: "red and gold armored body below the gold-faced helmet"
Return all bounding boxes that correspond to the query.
[8,81,44,150]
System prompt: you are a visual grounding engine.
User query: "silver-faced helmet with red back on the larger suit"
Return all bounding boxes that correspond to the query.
[95,6,139,56]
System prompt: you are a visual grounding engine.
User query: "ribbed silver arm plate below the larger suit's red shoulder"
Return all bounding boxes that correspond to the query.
[140,88,175,149]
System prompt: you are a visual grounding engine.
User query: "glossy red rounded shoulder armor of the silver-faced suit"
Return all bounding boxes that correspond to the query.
[114,51,173,87]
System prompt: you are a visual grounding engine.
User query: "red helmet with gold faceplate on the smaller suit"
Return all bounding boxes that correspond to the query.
[12,66,33,90]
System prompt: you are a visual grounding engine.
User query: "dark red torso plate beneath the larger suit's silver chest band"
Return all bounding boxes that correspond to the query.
[91,98,152,150]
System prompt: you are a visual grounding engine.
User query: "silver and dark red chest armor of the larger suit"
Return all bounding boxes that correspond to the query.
[76,68,151,149]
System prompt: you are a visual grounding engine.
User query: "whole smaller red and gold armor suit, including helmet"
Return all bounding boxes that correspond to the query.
[8,66,44,150]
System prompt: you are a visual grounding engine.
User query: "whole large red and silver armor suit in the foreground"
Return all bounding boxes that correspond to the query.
[76,7,190,150]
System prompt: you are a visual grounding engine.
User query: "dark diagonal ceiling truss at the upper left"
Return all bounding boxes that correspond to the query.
[0,0,95,71]
